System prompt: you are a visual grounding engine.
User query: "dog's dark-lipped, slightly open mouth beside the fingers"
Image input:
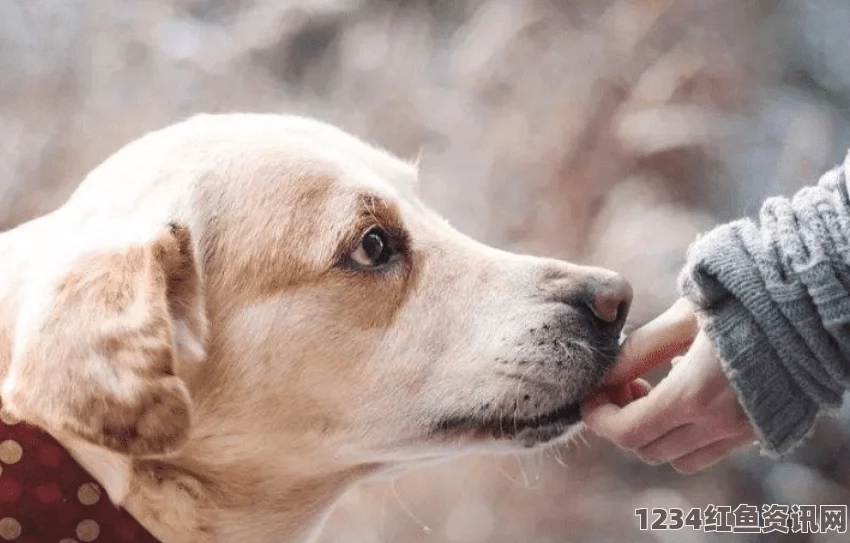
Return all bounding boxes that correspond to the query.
[434,402,581,447]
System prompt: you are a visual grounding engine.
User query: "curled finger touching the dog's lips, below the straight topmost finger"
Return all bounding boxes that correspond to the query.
[582,388,681,450]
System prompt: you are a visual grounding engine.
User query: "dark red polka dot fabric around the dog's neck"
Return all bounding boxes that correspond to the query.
[0,406,158,543]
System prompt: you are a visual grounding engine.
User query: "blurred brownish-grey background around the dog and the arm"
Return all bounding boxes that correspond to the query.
[0,0,850,543]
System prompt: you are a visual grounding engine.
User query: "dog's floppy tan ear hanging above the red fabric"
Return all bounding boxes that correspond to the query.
[2,225,206,456]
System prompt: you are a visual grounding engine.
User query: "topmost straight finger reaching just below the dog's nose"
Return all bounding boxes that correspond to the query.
[603,298,699,385]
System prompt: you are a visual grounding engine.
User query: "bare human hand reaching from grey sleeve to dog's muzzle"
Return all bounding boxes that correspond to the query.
[582,299,755,473]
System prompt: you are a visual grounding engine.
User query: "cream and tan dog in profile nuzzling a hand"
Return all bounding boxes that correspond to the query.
[0,114,632,543]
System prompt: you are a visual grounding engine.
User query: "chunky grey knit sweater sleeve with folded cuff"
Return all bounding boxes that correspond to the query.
[679,155,850,454]
